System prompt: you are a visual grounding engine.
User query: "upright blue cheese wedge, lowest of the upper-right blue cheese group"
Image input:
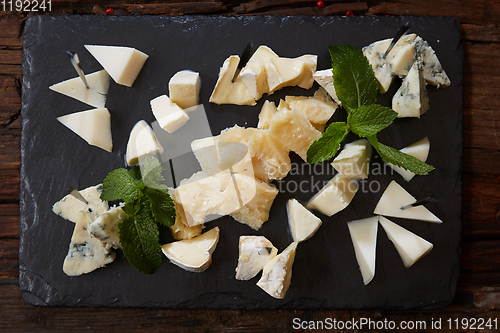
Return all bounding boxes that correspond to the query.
[392,61,429,118]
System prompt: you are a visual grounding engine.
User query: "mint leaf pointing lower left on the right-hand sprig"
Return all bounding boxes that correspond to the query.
[307,122,349,164]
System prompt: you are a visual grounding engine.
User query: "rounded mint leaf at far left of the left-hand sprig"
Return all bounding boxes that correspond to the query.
[101,169,142,202]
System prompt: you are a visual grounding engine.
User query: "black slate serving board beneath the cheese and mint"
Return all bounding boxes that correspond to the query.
[19,15,462,309]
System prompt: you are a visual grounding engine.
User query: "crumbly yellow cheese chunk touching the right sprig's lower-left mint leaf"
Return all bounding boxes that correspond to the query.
[269,109,321,161]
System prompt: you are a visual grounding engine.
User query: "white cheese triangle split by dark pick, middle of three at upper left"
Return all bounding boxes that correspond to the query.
[49,70,109,108]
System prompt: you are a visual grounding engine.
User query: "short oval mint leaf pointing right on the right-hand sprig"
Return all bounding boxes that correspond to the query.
[347,104,397,138]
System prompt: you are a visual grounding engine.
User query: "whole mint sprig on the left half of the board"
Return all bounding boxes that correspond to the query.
[101,156,176,274]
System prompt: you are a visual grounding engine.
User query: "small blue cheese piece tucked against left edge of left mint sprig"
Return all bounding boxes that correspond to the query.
[88,204,128,249]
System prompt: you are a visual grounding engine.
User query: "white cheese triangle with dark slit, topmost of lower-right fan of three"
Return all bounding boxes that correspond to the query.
[373,180,443,223]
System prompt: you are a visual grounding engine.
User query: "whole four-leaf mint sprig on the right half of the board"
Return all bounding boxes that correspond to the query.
[307,45,434,175]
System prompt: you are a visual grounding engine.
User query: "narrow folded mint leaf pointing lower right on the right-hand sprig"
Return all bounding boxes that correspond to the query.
[368,135,434,175]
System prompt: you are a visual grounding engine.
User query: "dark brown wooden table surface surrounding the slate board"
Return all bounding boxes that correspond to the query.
[0,0,500,332]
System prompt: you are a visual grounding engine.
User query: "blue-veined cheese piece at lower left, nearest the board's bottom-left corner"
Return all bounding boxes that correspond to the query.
[63,210,116,276]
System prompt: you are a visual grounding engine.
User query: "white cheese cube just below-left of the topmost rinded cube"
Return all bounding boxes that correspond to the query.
[149,95,189,133]
